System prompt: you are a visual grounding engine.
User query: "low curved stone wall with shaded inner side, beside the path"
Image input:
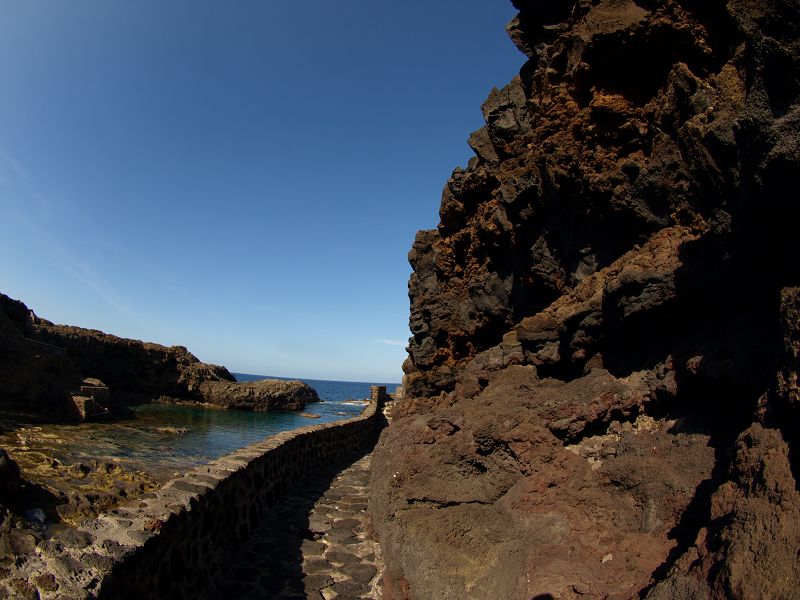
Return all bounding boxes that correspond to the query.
[15,395,384,600]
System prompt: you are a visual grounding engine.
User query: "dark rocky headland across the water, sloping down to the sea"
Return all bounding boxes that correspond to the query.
[0,294,319,418]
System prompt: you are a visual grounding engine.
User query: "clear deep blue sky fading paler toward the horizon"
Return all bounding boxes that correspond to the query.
[0,0,524,383]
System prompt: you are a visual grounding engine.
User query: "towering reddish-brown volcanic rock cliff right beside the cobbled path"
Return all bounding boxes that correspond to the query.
[371,0,800,599]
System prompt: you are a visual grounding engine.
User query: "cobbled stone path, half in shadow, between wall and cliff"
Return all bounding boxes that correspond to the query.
[219,454,383,600]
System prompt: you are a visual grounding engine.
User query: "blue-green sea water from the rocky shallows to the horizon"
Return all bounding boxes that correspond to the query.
[0,374,396,476]
